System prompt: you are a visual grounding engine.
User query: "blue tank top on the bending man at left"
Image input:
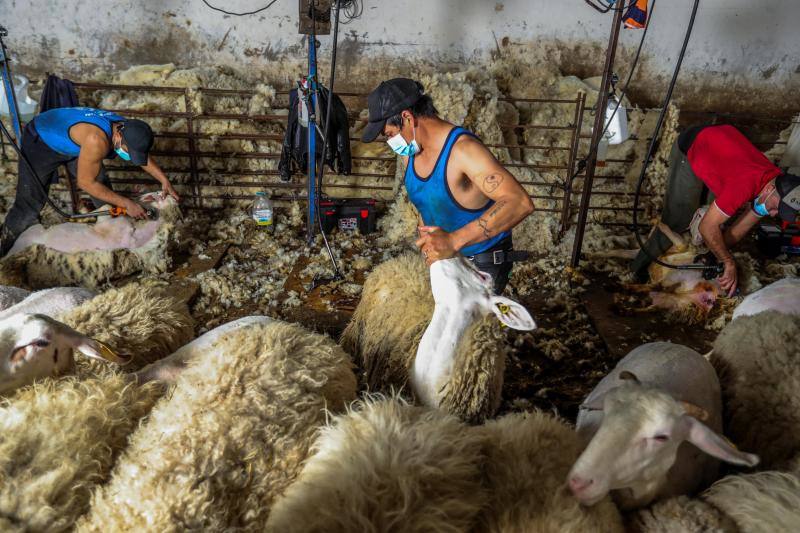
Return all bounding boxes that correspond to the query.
[33,107,125,157]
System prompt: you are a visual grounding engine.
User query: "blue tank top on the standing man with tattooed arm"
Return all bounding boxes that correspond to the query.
[405,127,509,256]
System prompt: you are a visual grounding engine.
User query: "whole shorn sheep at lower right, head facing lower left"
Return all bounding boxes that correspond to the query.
[568,342,758,509]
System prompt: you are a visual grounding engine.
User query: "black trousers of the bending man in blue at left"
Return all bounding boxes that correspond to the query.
[0,122,111,249]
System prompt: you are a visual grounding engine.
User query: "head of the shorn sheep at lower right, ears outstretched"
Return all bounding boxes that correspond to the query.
[567,378,758,508]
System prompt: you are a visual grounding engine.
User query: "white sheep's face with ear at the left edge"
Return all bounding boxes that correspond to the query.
[0,314,119,394]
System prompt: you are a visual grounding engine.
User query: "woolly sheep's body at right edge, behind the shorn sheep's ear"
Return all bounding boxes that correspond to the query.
[712,311,800,468]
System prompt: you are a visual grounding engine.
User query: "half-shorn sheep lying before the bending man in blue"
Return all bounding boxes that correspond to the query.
[0,193,180,288]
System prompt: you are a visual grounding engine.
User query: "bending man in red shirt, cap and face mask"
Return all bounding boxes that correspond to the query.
[631,125,800,296]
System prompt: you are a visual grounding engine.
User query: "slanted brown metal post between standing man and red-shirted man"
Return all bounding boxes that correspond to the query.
[570,0,625,268]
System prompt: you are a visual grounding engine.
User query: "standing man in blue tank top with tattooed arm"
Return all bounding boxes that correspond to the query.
[362,78,533,294]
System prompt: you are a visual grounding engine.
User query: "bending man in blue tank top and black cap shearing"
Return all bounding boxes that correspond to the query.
[0,107,178,257]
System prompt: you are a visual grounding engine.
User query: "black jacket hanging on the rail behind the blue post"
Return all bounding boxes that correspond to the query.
[278,86,352,181]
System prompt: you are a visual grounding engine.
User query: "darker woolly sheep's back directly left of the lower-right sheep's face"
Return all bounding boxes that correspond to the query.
[470,412,623,533]
